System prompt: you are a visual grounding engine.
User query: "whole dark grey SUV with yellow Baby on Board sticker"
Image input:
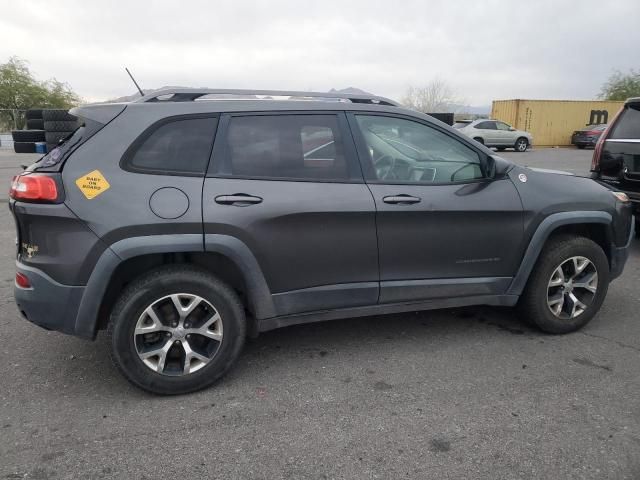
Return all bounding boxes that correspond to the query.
[10,89,634,394]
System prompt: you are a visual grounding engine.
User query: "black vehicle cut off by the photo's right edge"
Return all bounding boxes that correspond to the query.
[591,97,640,237]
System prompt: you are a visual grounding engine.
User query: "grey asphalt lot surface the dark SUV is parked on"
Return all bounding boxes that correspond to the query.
[0,149,640,479]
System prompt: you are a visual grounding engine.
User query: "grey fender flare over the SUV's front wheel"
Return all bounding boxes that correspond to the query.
[507,211,613,295]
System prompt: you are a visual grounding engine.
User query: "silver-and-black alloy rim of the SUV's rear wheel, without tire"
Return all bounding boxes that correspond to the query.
[133,293,223,376]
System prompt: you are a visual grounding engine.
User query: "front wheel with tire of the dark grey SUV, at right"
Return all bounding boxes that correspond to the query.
[518,235,609,333]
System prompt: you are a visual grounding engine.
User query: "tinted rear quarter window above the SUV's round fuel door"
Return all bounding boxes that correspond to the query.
[121,117,217,176]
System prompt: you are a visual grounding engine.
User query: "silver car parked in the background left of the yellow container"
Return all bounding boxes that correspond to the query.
[456,119,533,152]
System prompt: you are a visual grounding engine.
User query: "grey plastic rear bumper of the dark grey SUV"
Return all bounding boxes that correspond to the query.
[14,261,91,338]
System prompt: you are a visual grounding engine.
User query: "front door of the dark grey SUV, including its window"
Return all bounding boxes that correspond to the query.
[349,113,523,303]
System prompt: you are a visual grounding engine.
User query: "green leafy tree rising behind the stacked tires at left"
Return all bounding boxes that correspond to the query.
[0,57,80,128]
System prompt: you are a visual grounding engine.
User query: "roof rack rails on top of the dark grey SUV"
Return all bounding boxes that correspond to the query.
[134,88,400,107]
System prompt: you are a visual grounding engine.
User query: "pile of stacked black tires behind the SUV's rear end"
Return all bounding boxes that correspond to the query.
[11,108,78,153]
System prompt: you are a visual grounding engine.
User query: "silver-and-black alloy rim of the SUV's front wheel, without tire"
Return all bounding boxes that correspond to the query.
[547,256,598,320]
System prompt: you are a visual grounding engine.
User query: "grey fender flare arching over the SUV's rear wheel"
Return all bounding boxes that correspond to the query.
[75,234,275,338]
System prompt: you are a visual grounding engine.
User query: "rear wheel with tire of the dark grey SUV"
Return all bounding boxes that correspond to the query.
[108,266,246,395]
